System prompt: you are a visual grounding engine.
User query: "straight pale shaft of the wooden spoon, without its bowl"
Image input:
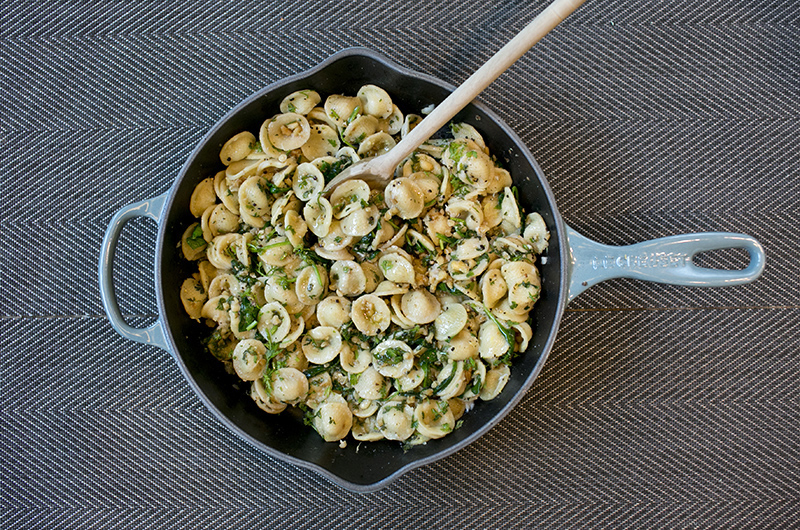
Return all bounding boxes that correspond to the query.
[382,0,586,173]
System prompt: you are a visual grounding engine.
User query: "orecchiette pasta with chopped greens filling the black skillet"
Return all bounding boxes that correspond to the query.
[180,85,549,446]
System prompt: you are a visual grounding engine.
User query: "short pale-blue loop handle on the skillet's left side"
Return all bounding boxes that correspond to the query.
[99,193,171,353]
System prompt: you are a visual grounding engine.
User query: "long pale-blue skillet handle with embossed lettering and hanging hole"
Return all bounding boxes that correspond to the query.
[567,226,765,300]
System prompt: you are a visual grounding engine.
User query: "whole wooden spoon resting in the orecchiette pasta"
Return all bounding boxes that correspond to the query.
[324,0,585,193]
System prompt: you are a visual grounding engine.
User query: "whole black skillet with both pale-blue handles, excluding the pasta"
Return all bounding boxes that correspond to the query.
[99,48,764,492]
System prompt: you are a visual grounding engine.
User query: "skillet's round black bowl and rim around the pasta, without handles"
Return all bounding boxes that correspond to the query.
[156,49,566,491]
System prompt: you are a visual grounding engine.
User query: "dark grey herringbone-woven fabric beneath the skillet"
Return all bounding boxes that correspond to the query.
[0,0,800,528]
